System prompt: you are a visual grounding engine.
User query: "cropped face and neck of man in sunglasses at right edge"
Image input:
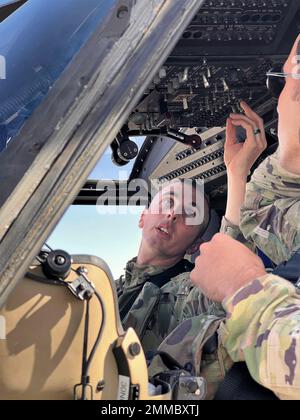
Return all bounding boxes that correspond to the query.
[278,35,300,139]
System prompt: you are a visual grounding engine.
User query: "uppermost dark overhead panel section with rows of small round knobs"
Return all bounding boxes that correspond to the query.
[175,0,300,56]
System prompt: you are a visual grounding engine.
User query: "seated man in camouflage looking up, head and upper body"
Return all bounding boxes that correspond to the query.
[119,181,223,353]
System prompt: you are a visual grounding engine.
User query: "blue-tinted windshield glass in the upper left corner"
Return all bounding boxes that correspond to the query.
[0,0,116,153]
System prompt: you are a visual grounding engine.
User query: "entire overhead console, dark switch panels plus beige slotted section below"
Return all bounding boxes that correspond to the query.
[128,0,300,203]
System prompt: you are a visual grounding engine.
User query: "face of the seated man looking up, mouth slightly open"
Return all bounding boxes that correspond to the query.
[140,182,205,257]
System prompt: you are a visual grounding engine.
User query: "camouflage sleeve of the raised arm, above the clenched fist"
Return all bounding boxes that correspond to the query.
[240,152,300,264]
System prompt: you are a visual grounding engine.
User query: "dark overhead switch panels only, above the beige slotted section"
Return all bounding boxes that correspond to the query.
[129,0,300,134]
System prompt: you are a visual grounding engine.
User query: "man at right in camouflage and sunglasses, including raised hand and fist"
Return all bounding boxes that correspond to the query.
[203,36,300,399]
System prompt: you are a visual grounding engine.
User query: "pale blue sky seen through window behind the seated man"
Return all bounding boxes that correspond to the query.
[47,140,143,279]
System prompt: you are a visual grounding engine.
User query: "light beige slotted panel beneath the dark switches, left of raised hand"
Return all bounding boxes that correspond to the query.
[132,127,226,200]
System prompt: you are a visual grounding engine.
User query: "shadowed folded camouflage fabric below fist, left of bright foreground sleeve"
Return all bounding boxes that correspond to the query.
[148,315,233,400]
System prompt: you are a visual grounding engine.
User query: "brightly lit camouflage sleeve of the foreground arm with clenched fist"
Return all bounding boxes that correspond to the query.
[220,274,300,400]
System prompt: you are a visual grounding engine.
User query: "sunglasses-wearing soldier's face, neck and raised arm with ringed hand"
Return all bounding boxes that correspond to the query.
[222,36,300,265]
